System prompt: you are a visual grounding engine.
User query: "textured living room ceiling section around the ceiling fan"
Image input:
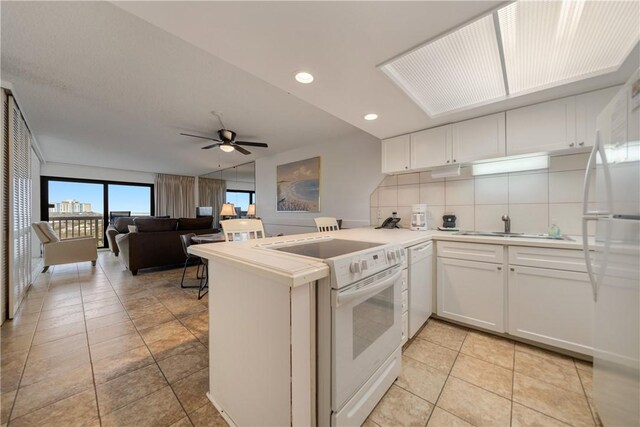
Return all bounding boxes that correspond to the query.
[1,2,360,174]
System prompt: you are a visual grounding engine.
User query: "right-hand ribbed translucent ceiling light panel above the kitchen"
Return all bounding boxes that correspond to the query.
[497,0,640,95]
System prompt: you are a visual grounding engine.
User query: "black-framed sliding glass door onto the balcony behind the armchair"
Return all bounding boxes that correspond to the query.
[40,177,153,248]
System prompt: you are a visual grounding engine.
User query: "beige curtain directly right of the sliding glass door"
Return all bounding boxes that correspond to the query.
[154,173,196,218]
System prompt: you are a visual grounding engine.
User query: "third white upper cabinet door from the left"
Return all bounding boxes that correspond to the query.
[451,113,506,163]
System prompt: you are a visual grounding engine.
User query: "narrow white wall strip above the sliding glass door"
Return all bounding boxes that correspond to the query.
[40,162,155,184]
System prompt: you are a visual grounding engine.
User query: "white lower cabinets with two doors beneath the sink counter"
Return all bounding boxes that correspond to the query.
[436,241,595,355]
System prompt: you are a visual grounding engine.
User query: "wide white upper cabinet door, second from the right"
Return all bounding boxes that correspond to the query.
[507,96,576,156]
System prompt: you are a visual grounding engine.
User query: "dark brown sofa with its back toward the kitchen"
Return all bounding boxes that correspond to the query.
[115,217,220,276]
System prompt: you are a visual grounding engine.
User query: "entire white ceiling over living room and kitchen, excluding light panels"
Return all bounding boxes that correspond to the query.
[0,1,638,174]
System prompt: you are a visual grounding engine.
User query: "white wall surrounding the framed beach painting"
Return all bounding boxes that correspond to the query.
[256,132,383,234]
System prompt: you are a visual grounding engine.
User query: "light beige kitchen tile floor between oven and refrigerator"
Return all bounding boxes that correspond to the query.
[365,319,599,427]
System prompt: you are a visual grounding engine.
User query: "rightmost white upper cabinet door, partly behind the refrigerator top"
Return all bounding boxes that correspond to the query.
[576,86,620,147]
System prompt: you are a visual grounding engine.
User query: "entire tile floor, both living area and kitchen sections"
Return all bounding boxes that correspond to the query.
[0,252,597,427]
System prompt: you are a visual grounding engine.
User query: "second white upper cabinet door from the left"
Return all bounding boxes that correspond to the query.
[411,125,453,169]
